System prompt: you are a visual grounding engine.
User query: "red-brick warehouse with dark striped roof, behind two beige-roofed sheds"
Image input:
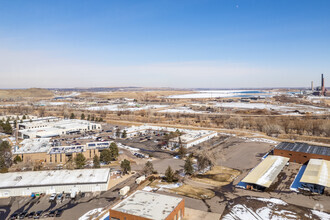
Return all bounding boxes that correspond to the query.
[274,142,330,164]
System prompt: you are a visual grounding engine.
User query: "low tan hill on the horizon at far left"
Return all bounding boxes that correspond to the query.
[0,88,54,99]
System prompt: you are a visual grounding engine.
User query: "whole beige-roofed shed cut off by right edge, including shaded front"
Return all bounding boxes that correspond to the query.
[300,159,330,194]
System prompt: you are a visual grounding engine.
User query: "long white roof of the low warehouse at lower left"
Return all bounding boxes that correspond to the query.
[0,169,110,189]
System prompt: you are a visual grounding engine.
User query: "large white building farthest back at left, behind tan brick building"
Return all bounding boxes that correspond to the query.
[18,119,102,139]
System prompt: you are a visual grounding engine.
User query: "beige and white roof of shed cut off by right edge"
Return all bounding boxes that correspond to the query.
[300,159,330,187]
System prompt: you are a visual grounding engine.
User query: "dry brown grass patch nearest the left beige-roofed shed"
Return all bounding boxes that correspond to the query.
[192,166,241,187]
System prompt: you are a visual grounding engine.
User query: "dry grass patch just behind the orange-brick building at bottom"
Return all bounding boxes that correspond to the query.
[169,185,215,199]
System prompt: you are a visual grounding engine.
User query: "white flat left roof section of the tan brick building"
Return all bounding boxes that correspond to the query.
[14,138,51,154]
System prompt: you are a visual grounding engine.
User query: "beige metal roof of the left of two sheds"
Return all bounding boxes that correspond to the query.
[242,155,290,188]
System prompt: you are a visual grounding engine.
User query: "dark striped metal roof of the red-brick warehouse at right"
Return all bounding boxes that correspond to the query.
[275,142,330,156]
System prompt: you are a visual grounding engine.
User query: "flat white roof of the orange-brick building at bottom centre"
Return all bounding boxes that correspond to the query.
[111,190,183,220]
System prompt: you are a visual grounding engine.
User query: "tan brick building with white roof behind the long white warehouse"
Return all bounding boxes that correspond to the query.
[13,138,111,164]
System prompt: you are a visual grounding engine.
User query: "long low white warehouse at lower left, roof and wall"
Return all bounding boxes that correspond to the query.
[0,169,110,198]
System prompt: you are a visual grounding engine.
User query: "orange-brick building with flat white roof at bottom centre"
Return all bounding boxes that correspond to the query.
[109,190,185,220]
